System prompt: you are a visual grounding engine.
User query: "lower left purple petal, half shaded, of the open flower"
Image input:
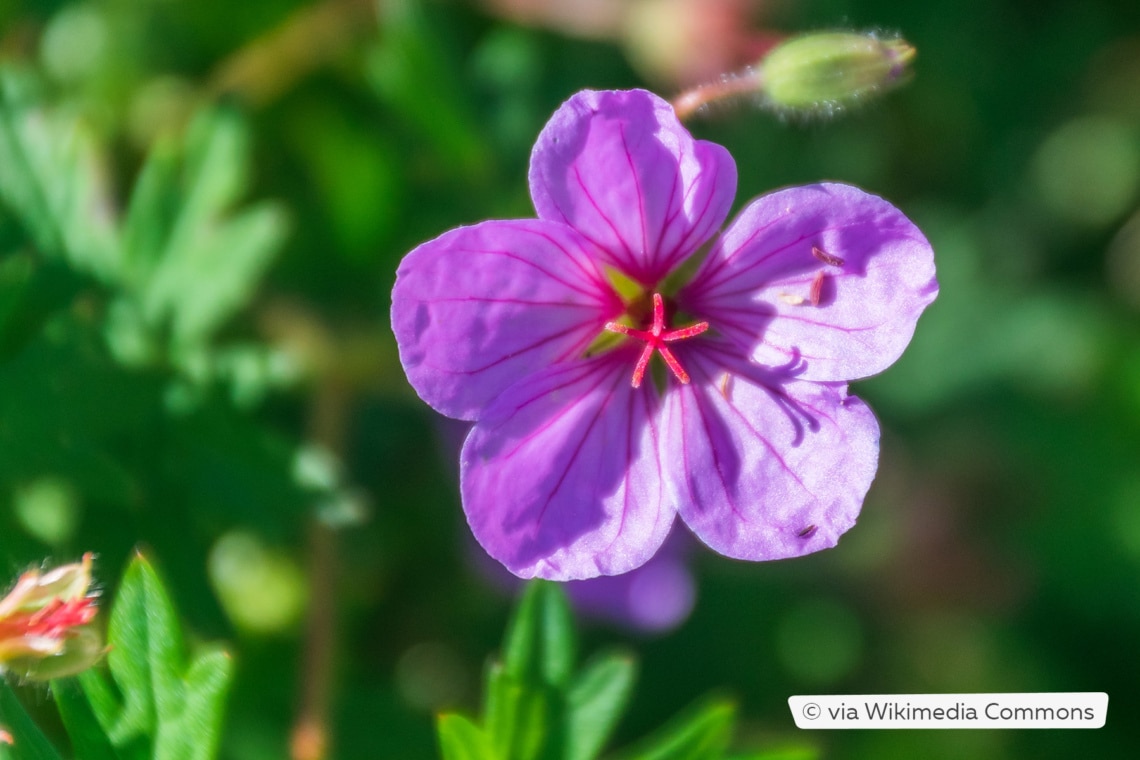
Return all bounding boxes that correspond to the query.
[461,349,675,580]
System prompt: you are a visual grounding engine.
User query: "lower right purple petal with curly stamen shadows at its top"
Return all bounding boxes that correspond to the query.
[662,346,879,559]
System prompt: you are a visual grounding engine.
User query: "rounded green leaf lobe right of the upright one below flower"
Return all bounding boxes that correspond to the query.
[564,653,637,760]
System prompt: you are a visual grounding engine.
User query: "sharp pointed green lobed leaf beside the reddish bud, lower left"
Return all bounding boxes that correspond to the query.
[81,556,233,760]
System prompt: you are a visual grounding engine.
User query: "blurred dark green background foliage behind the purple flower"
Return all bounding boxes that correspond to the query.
[0,0,1140,760]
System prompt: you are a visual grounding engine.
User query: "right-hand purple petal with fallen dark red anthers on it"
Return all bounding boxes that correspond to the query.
[677,185,938,381]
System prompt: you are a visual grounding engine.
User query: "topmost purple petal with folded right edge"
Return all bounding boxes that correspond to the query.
[530,90,736,285]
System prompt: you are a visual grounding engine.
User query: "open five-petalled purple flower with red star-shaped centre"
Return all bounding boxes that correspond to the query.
[392,90,938,580]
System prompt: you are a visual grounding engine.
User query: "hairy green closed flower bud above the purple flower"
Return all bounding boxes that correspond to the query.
[760,32,914,115]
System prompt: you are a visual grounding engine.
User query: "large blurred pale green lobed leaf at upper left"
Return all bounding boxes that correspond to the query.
[0,68,287,363]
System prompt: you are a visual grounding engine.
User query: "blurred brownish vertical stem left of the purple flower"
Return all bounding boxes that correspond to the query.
[290,382,352,760]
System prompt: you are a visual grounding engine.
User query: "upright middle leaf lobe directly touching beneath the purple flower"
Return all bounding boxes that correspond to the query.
[503,581,578,688]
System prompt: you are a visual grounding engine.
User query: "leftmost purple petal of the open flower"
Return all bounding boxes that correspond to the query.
[392,220,621,419]
